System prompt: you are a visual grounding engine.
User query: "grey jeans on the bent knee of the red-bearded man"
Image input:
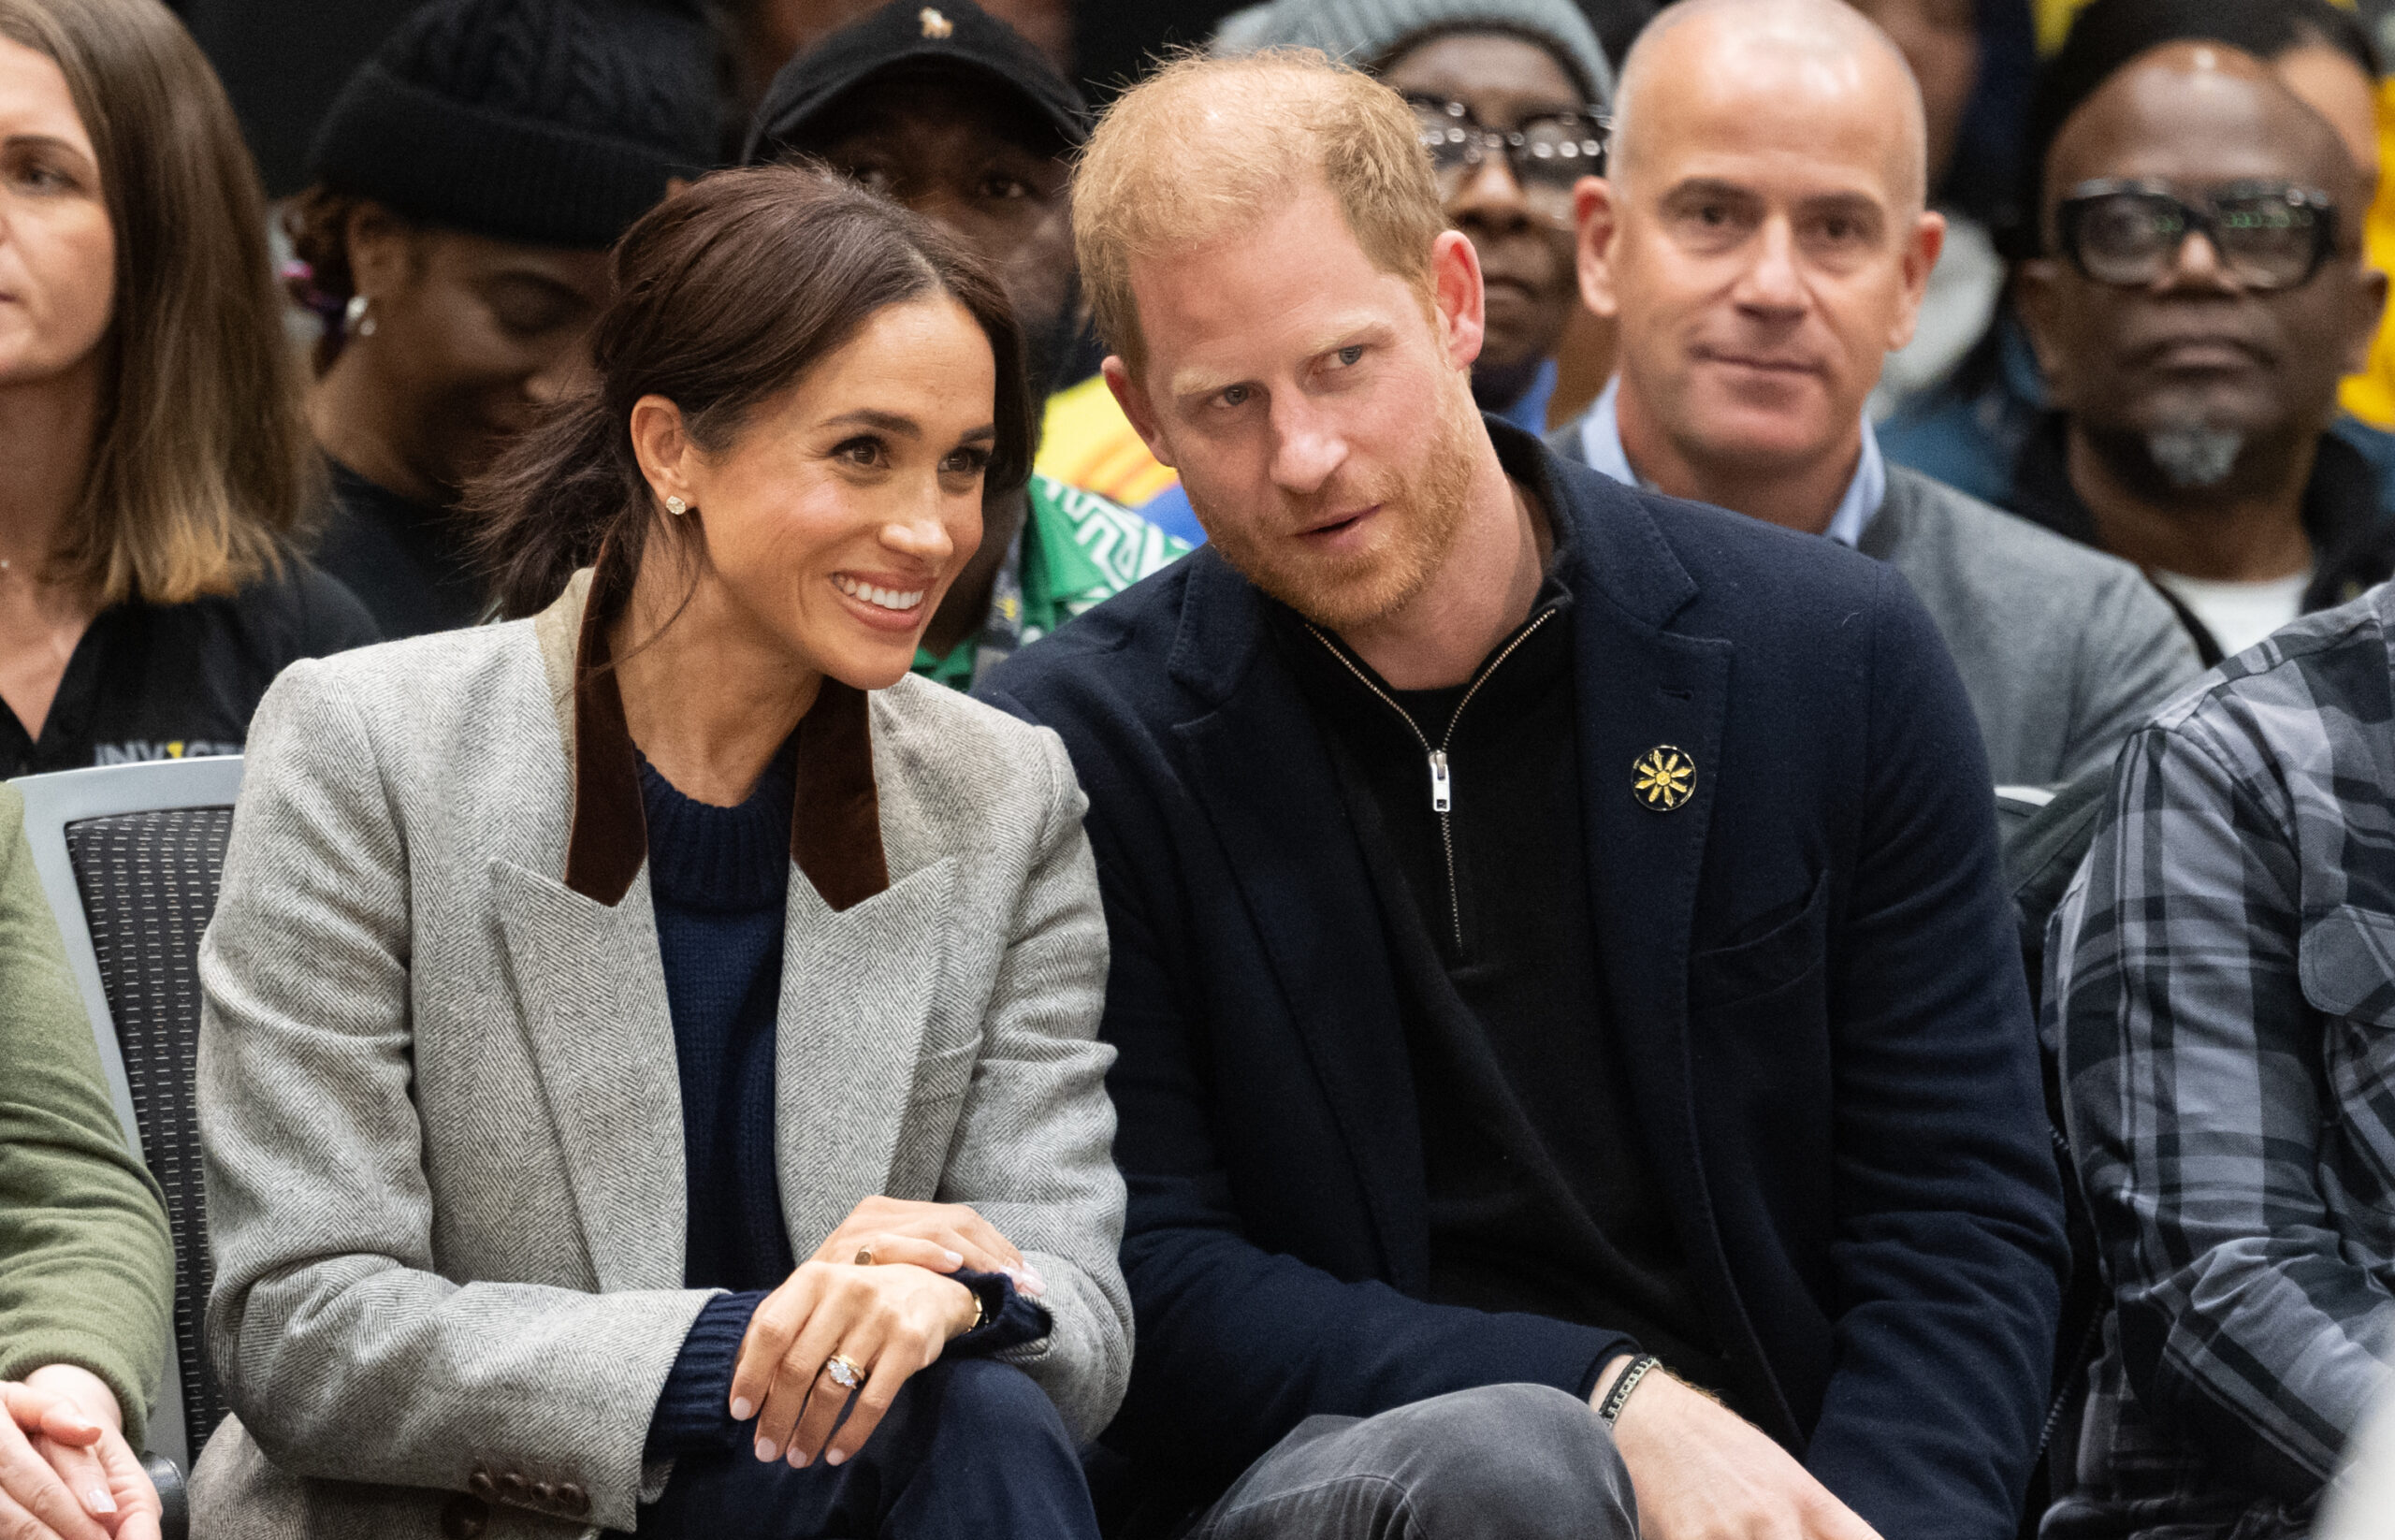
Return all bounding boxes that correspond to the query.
[1188,1385,1638,1540]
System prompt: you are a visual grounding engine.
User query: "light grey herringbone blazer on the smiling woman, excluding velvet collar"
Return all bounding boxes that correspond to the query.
[192,574,1130,1540]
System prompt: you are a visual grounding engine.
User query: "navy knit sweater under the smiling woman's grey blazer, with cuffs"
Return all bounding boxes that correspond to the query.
[640,735,1049,1454]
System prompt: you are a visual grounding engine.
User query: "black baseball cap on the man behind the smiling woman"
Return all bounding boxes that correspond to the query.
[740,0,1090,166]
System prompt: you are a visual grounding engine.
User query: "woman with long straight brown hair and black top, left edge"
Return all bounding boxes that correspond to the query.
[0,0,373,776]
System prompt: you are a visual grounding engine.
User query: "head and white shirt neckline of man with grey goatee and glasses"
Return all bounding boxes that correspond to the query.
[2014,43,2386,659]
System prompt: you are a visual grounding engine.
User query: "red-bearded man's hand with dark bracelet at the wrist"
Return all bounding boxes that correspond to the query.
[1590,1358,1880,1540]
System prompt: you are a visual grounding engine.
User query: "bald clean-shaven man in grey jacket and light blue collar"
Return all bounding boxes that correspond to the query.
[1554,0,2199,786]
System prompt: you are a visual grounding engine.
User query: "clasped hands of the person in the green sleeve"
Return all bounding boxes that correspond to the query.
[0,1363,158,1540]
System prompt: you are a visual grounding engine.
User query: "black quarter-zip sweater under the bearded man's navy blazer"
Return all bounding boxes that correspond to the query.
[1270,548,1727,1391]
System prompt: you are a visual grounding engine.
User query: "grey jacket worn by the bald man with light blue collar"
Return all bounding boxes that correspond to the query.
[1547,422,2203,786]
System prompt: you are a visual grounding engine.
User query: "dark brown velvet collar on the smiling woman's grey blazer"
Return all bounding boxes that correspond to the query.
[565,556,891,910]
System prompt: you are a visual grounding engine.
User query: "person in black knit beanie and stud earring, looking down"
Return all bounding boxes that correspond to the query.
[285,0,721,637]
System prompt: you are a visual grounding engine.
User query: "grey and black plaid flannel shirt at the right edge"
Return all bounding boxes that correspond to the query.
[2043,585,2395,1540]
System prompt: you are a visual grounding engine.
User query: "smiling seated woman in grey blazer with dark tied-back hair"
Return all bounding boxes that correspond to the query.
[194,167,1130,1540]
